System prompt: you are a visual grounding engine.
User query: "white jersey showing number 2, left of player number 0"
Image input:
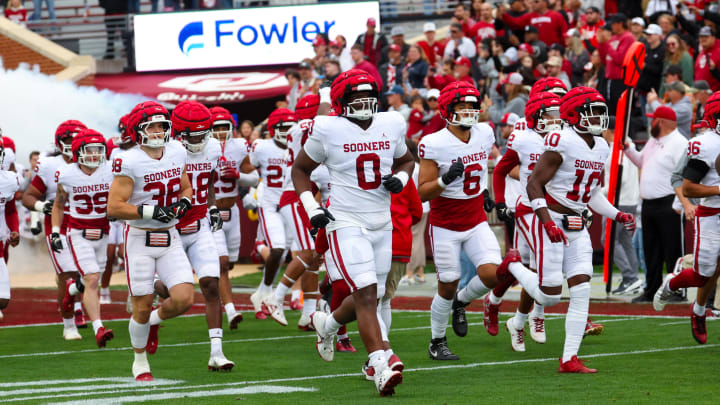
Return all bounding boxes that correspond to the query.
[250,139,287,210]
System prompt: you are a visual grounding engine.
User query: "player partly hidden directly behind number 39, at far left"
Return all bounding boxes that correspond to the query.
[22,120,87,340]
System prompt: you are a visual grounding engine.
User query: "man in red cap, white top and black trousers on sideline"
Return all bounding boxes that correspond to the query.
[625,106,694,303]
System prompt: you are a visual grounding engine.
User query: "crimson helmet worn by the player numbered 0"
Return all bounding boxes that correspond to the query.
[330,69,378,121]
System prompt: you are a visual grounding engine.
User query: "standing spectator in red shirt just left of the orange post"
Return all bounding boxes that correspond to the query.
[597,13,635,115]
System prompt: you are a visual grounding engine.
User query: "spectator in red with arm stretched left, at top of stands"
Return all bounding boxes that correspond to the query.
[498,0,568,46]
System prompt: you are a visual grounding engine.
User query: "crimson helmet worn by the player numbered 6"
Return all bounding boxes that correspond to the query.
[438,81,482,128]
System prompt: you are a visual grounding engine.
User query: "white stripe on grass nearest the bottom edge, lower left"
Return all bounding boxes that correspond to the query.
[50,385,317,405]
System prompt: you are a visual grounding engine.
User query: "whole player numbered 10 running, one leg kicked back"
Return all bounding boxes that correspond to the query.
[498,87,635,373]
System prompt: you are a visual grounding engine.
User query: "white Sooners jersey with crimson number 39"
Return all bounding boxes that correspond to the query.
[57,162,113,229]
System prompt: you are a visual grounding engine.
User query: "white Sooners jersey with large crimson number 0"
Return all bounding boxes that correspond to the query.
[304,112,407,230]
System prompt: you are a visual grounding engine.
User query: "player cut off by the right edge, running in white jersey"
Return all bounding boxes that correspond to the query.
[653,92,720,344]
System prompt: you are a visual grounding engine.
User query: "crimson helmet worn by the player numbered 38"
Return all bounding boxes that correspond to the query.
[128,101,172,148]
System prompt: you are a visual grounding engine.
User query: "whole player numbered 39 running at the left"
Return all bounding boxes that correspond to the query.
[50,129,113,347]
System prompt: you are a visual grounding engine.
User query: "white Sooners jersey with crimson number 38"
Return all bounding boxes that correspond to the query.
[112,142,187,229]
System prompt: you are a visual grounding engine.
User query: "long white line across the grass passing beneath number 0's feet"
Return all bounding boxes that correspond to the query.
[6,343,720,404]
